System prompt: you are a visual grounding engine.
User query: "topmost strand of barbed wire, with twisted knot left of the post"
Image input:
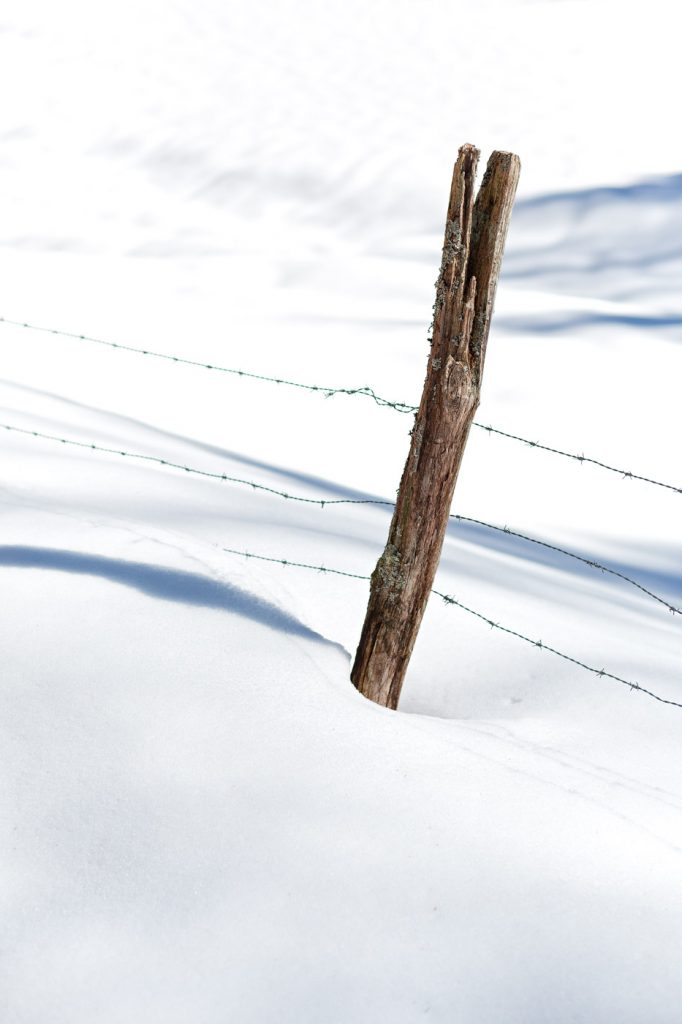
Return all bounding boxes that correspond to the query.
[0,316,682,494]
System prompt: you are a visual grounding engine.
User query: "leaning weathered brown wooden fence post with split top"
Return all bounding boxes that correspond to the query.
[350,145,520,708]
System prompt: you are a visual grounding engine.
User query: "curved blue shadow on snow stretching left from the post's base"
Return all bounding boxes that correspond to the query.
[0,545,329,643]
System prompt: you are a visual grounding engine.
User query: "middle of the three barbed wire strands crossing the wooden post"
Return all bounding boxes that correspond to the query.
[0,423,682,614]
